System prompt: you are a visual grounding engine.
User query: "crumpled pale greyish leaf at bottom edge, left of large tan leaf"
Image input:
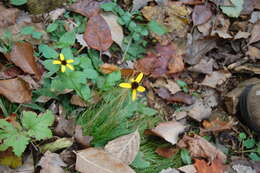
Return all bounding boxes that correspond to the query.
[38,151,67,173]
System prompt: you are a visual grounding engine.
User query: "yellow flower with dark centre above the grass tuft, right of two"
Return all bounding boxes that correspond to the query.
[119,73,145,101]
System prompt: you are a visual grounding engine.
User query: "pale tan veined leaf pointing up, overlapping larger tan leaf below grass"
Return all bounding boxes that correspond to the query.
[105,131,140,165]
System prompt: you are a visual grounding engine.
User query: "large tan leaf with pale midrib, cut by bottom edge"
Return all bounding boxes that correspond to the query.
[76,148,135,173]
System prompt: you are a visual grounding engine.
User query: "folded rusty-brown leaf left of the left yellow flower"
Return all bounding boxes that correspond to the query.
[6,42,40,79]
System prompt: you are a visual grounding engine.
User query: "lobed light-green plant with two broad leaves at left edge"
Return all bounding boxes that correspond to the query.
[0,111,54,156]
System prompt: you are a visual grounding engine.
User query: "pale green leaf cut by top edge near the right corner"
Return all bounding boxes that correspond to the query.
[220,0,244,17]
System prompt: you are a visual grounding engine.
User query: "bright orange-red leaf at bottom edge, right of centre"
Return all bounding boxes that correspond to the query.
[194,159,226,173]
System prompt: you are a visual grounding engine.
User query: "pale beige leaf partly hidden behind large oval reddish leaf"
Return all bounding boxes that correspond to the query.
[100,12,124,48]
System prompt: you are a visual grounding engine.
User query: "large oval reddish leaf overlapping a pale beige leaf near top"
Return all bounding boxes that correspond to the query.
[84,15,113,51]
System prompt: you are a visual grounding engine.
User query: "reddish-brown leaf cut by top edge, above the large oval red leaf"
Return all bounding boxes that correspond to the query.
[70,0,100,17]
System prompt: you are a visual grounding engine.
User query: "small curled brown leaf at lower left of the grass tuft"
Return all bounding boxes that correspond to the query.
[74,125,93,147]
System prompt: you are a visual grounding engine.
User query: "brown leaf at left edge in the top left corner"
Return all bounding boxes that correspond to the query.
[0,3,19,28]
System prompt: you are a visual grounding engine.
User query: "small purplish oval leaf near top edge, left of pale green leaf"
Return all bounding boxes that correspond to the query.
[192,4,212,25]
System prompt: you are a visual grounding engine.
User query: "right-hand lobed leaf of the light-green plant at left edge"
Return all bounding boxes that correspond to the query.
[21,111,55,140]
